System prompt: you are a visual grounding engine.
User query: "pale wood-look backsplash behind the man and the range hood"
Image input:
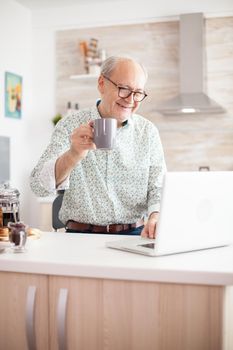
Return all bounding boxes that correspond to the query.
[56,17,233,170]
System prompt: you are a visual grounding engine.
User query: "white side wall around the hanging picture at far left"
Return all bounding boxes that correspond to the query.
[0,0,32,221]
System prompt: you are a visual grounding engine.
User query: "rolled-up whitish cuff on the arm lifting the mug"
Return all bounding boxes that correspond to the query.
[40,159,70,191]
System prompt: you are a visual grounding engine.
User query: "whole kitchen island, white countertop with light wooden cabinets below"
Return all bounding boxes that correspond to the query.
[0,232,233,350]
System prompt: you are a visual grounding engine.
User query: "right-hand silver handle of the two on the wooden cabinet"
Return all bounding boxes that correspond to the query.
[57,288,68,350]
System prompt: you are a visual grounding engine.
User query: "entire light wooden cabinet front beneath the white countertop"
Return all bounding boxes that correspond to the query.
[0,272,226,350]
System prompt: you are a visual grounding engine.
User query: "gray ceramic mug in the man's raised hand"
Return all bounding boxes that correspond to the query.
[93,118,117,149]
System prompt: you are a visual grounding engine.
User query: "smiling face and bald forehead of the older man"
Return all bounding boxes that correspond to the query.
[98,60,146,125]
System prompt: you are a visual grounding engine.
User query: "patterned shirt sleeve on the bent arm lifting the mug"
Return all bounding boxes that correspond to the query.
[30,121,70,197]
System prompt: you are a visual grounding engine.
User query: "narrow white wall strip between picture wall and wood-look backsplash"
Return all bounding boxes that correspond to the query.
[26,25,55,227]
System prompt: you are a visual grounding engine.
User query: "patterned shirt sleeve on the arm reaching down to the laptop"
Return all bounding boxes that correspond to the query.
[148,125,167,217]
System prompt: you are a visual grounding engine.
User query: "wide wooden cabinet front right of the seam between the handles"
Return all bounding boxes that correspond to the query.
[49,276,223,350]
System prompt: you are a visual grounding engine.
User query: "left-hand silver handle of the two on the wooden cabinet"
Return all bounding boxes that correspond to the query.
[26,286,36,350]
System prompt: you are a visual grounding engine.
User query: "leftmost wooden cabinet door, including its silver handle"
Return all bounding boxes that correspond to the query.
[0,272,49,350]
